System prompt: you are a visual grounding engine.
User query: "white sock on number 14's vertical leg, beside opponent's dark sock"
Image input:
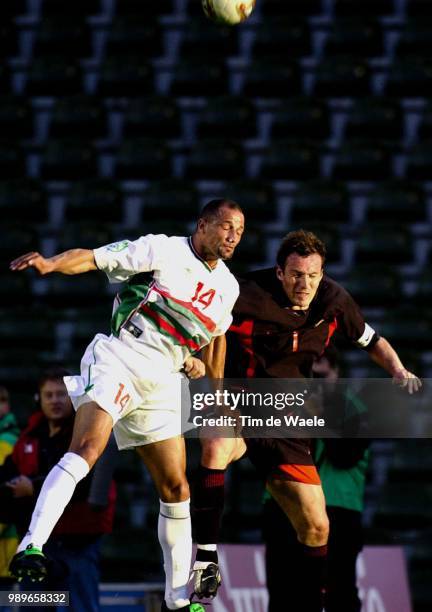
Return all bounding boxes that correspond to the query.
[158,499,192,610]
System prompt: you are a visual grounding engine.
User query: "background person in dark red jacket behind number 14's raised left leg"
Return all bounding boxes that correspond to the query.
[0,368,115,612]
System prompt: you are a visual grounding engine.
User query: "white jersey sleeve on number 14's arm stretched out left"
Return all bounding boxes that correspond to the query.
[93,234,169,283]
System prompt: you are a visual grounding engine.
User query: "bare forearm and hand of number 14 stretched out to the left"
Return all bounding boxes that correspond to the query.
[10,249,97,275]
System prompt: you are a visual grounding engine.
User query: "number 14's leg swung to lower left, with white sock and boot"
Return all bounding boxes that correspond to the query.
[10,402,113,579]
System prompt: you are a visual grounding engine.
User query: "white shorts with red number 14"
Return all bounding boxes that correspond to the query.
[64,334,189,450]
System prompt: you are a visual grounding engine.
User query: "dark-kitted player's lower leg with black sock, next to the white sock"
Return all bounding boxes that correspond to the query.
[193,437,246,597]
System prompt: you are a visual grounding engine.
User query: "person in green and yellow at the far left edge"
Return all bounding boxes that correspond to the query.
[0,385,19,596]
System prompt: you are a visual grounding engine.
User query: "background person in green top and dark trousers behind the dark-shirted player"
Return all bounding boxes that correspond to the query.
[263,347,369,612]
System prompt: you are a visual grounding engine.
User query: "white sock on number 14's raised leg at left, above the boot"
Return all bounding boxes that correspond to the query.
[18,453,90,552]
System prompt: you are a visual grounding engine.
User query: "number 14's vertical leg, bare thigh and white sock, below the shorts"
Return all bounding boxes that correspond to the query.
[137,436,197,610]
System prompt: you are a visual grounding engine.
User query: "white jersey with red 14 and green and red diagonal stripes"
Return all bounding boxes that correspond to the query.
[94,234,239,369]
